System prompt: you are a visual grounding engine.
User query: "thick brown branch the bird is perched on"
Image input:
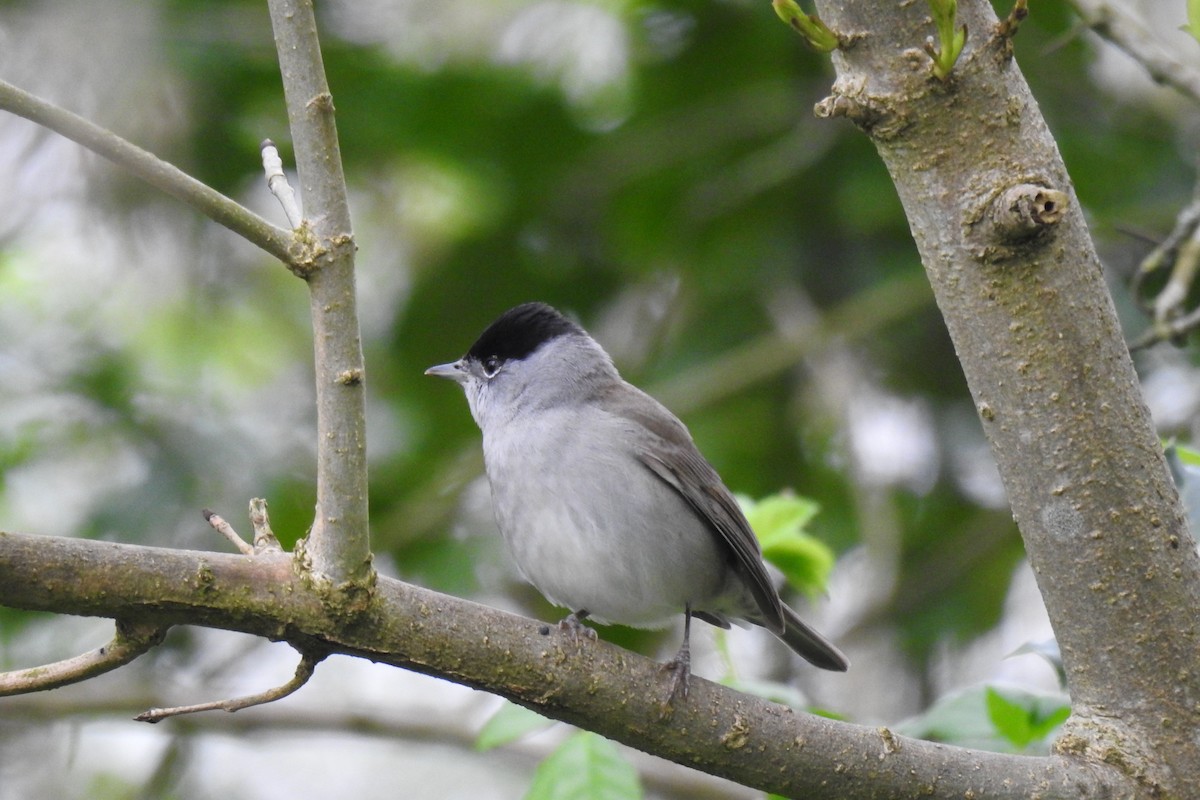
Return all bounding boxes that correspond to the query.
[0,533,1132,800]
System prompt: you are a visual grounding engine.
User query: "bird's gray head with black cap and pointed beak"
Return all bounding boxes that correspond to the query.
[425,302,620,429]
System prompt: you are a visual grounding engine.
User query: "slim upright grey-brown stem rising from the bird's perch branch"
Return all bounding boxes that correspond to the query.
[268,0,374,587]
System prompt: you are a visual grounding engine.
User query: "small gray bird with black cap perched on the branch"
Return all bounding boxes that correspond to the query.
[425,302,850,696]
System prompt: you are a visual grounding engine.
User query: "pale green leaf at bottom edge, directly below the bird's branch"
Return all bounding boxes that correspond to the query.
[524,730,642,800]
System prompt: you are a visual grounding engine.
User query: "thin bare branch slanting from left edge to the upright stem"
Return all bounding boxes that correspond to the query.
[0,75,295,264]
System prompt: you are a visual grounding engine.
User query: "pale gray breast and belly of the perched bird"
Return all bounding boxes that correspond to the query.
[484,407,728,626]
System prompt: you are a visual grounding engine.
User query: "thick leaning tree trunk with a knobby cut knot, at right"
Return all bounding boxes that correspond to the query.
[818,0,1200,798]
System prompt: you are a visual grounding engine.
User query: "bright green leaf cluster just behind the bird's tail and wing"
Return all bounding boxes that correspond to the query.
[738,493,835,595]
